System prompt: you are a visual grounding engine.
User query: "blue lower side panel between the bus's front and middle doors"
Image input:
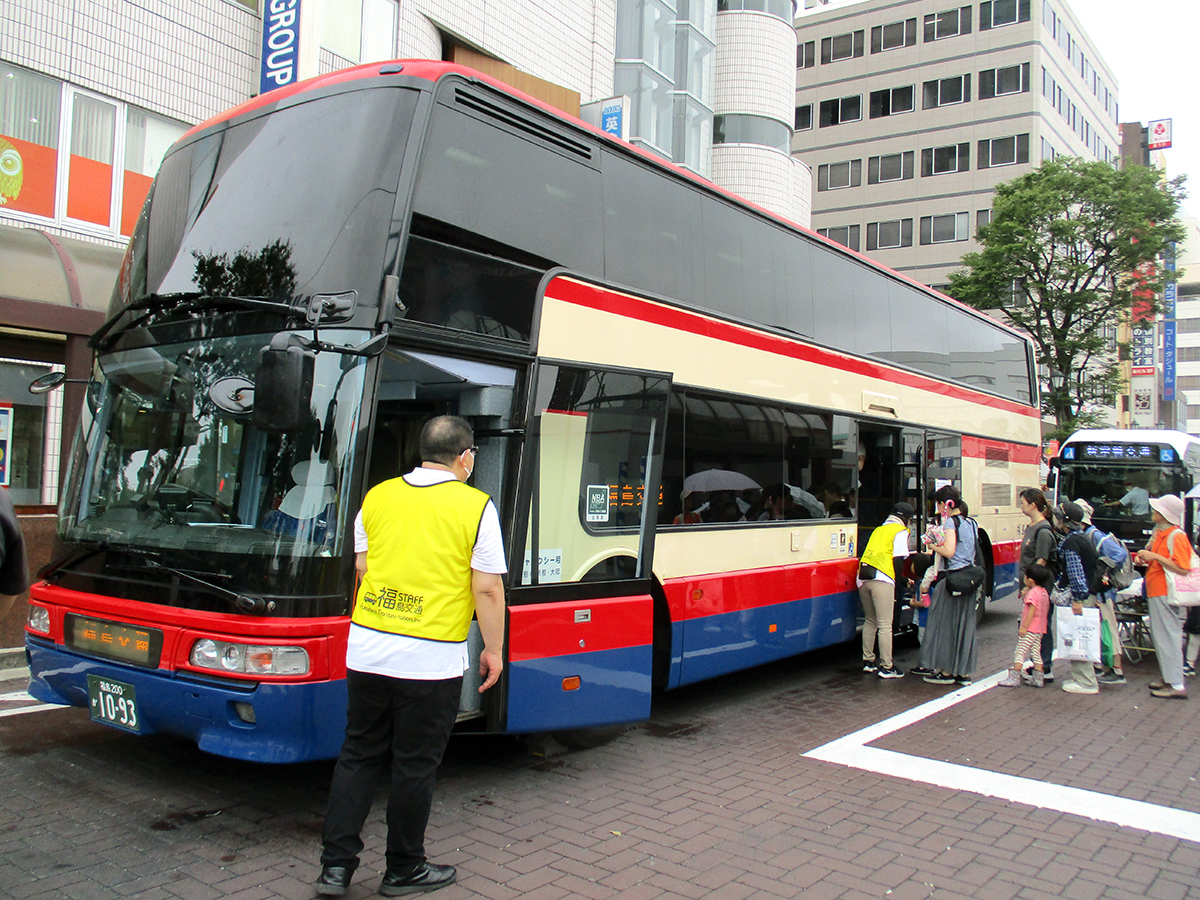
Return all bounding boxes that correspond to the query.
[671,592,858,688]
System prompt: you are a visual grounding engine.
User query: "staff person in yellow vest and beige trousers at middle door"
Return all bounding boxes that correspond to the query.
[858,503,916,678]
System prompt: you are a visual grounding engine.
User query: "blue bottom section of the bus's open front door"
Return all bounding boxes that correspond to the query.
[505,644,654,734]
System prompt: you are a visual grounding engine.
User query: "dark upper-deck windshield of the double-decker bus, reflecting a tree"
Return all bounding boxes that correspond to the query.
[109,89,416,314]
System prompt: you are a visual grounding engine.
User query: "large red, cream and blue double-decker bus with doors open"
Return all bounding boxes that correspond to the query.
[26,61,1039,762]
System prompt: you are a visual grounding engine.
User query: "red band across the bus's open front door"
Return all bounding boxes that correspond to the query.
[509,594,654,662]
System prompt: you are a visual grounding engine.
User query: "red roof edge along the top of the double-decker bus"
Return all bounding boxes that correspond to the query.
[180,59,1032,346]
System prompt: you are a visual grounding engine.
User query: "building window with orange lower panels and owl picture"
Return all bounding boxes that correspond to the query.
[0,62,186,238]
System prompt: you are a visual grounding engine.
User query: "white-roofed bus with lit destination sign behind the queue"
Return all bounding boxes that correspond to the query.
[1050,428,1200,550]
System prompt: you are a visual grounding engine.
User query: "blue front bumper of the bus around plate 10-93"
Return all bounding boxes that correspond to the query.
[25,638,346,763]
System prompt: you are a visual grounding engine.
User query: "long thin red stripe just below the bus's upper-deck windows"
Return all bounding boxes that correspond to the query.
[546,276,1040,418]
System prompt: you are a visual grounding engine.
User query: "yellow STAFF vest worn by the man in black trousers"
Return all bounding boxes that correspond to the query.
[350,478,488,642]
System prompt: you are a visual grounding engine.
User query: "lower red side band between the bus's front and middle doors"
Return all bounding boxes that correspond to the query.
[662,559,858,622]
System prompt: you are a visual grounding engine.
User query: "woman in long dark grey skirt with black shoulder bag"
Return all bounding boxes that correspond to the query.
[920,485,983,685]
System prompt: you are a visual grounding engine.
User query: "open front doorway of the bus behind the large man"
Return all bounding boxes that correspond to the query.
[366,349,520,720]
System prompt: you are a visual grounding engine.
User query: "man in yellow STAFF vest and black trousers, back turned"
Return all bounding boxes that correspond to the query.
[316,415,508,896]
